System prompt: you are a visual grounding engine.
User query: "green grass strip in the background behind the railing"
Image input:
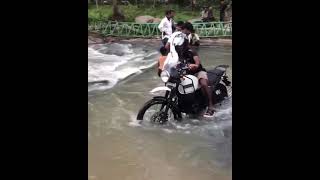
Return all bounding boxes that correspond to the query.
[88,5,219,22]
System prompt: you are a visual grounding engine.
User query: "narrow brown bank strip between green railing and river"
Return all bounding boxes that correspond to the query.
[88,32,232,46]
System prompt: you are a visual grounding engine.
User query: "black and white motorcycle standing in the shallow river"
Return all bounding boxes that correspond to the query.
[137,63,231,124]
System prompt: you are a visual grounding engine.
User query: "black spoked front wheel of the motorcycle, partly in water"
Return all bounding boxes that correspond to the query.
[137,99,174,125]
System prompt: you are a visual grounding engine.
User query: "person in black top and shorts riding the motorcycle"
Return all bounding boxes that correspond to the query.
[168,22,214,117]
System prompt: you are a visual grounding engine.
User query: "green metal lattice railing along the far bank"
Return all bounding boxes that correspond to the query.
[88,20,232,38]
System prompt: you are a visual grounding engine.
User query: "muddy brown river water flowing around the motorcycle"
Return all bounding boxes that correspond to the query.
[88,42,232,180]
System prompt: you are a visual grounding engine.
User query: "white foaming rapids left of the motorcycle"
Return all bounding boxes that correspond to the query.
[88,43,158,92]
